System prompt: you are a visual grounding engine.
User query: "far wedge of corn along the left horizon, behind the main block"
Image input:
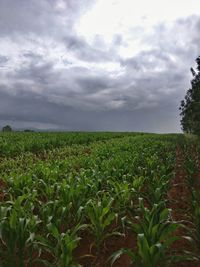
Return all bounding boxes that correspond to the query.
[0,132,141,157]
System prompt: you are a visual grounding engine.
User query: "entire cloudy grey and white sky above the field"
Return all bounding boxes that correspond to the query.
[0,0,200,133]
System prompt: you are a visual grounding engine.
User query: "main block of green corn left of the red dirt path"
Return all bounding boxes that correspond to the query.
[0,135,194,267]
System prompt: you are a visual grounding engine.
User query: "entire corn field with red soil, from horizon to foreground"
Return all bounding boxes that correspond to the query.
[0,132,200,267]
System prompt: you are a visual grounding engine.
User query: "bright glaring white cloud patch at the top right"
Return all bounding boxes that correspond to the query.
[76,0,200,57]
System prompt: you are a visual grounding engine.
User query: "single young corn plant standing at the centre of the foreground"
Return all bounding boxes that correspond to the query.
[85,195,119,253]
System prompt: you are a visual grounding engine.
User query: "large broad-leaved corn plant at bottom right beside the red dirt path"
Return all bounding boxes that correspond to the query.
[111,198,182,267]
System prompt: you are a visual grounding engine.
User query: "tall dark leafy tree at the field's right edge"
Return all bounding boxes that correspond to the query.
[179,56,200,135]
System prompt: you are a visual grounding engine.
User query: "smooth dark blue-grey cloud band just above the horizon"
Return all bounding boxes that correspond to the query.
[0,88,178,132]
